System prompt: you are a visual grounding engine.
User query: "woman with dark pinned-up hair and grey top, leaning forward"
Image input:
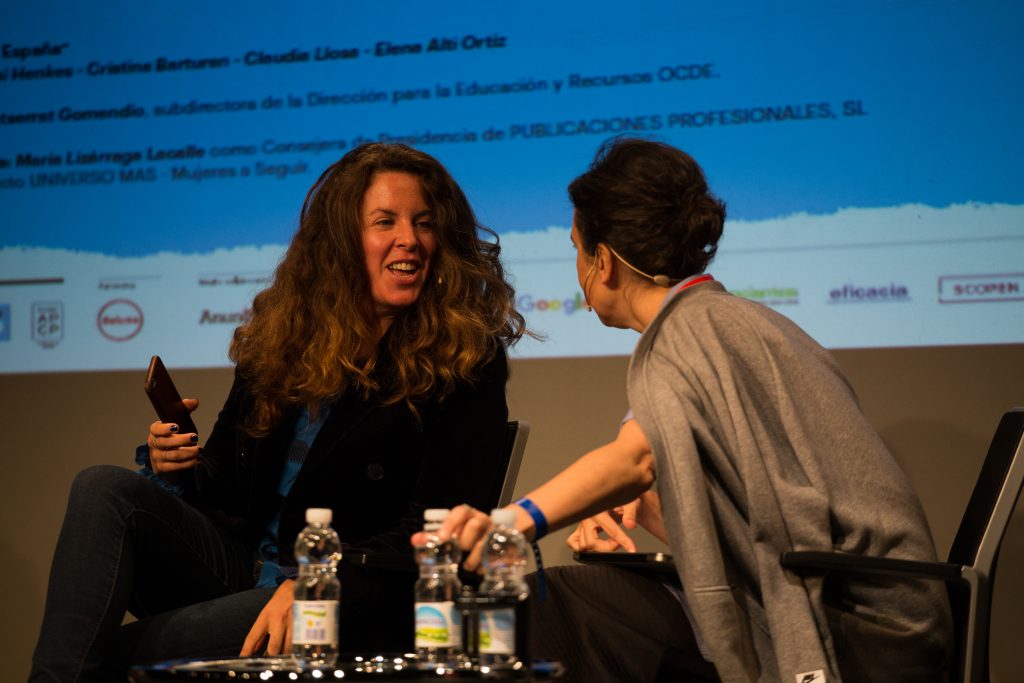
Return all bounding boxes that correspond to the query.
[419,139,950,683]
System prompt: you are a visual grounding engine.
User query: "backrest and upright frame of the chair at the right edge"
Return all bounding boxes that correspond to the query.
[948,408,1024,683]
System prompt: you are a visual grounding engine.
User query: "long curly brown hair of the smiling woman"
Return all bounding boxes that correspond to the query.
[229,143,525,436]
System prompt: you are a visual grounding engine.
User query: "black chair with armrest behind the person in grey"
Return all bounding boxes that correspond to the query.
[779,408,1024,683]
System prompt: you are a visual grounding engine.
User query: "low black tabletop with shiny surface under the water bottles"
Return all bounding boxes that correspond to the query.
[129,654,564,683]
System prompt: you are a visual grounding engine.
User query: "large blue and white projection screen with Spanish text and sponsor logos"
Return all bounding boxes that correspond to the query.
[0,0,1024,373]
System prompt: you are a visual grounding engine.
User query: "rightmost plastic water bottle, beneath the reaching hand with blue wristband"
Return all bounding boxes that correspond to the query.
[477,509,530,667]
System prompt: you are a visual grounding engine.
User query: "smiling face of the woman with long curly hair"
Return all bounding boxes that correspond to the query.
[360,171,437,332]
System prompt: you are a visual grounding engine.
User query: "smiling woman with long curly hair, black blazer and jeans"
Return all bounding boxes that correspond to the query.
[31,143,524,682]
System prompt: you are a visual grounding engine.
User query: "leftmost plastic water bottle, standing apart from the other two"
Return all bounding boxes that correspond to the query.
[292,508,341,667]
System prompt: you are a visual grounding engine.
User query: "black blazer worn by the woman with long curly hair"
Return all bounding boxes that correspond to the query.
[185,343,508,566]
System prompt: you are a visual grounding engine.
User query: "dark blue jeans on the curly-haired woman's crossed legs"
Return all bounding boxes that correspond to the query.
[30,466,273,683]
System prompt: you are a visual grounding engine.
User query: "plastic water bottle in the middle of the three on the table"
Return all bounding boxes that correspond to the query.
[416,509,462,668]
